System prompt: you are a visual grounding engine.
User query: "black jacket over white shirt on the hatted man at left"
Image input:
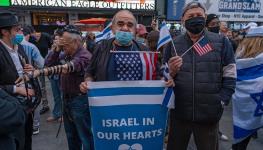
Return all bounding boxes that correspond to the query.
[0,42,28,94]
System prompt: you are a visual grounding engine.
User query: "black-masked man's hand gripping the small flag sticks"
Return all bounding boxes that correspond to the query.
[168,56,183,78]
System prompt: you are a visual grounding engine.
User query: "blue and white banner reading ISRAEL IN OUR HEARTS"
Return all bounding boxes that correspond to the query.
[88,80,174,150]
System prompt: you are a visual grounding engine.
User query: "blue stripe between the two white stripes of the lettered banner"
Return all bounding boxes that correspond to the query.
[88,87,164,97]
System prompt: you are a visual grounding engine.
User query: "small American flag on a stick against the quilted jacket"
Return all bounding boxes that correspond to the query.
[193,36,213,56]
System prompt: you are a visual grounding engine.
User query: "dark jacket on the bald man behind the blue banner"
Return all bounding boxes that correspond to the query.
[85,38,149,81]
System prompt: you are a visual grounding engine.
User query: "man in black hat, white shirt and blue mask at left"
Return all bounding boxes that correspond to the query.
[0,11,35,150]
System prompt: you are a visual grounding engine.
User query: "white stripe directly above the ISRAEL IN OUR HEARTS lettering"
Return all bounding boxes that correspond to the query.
[89,94,164,106]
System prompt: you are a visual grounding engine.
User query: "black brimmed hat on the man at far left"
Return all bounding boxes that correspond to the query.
[0,10,18,28]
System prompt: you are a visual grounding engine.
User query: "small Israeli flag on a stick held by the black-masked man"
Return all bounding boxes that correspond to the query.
[157,21,172,50]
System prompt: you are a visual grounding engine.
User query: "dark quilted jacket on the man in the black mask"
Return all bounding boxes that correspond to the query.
[164,31,236,123]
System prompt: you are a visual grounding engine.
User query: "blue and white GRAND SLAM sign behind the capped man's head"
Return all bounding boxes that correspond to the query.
[167,0,263,22]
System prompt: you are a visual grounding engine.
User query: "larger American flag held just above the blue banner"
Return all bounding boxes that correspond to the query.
[112,51,158,81]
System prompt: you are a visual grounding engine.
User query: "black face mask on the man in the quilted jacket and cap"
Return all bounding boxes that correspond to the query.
[185,17,205,34]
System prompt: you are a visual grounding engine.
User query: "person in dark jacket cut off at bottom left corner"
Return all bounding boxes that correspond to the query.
[0,89,26,150]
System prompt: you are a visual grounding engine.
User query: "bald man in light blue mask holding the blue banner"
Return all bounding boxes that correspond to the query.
[79,10,148,83]
